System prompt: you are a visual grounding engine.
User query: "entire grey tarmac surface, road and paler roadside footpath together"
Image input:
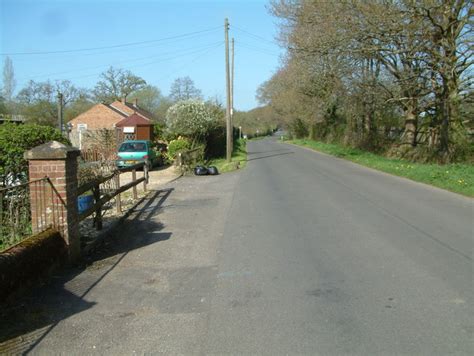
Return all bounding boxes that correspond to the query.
[0,139,474,355]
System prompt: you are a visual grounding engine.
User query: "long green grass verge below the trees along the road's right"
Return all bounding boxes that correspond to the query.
[286,140,474,197]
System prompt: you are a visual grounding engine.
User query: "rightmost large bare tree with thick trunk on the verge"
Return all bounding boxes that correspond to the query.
[408,0,474,159]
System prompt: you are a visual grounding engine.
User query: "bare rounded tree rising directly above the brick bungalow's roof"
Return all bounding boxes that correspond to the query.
[93,67,146,102]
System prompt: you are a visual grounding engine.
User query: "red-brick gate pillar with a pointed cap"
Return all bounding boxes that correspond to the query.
[24,141,81,261]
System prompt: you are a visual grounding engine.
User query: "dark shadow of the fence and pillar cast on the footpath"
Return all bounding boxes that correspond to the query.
[0,189,173,354]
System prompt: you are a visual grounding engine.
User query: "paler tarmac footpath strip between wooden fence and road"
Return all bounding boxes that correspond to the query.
[0,168,239,355]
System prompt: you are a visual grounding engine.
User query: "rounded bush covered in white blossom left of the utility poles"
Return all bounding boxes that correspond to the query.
[166,100,219,148]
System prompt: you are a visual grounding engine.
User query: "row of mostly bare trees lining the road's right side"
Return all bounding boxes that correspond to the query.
[266,0,474,161]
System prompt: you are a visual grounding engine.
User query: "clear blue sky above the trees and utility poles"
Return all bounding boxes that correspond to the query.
[0,0,283,110]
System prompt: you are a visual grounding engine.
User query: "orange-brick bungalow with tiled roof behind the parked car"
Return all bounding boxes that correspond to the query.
[69,99,153,149]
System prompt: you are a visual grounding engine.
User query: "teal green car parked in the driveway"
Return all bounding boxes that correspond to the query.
[117,140,157,169]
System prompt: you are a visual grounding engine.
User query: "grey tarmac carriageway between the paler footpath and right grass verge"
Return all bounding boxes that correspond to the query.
[206,139,474,355]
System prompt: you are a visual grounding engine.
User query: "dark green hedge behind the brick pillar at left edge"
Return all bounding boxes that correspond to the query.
[0,123,68,184]
